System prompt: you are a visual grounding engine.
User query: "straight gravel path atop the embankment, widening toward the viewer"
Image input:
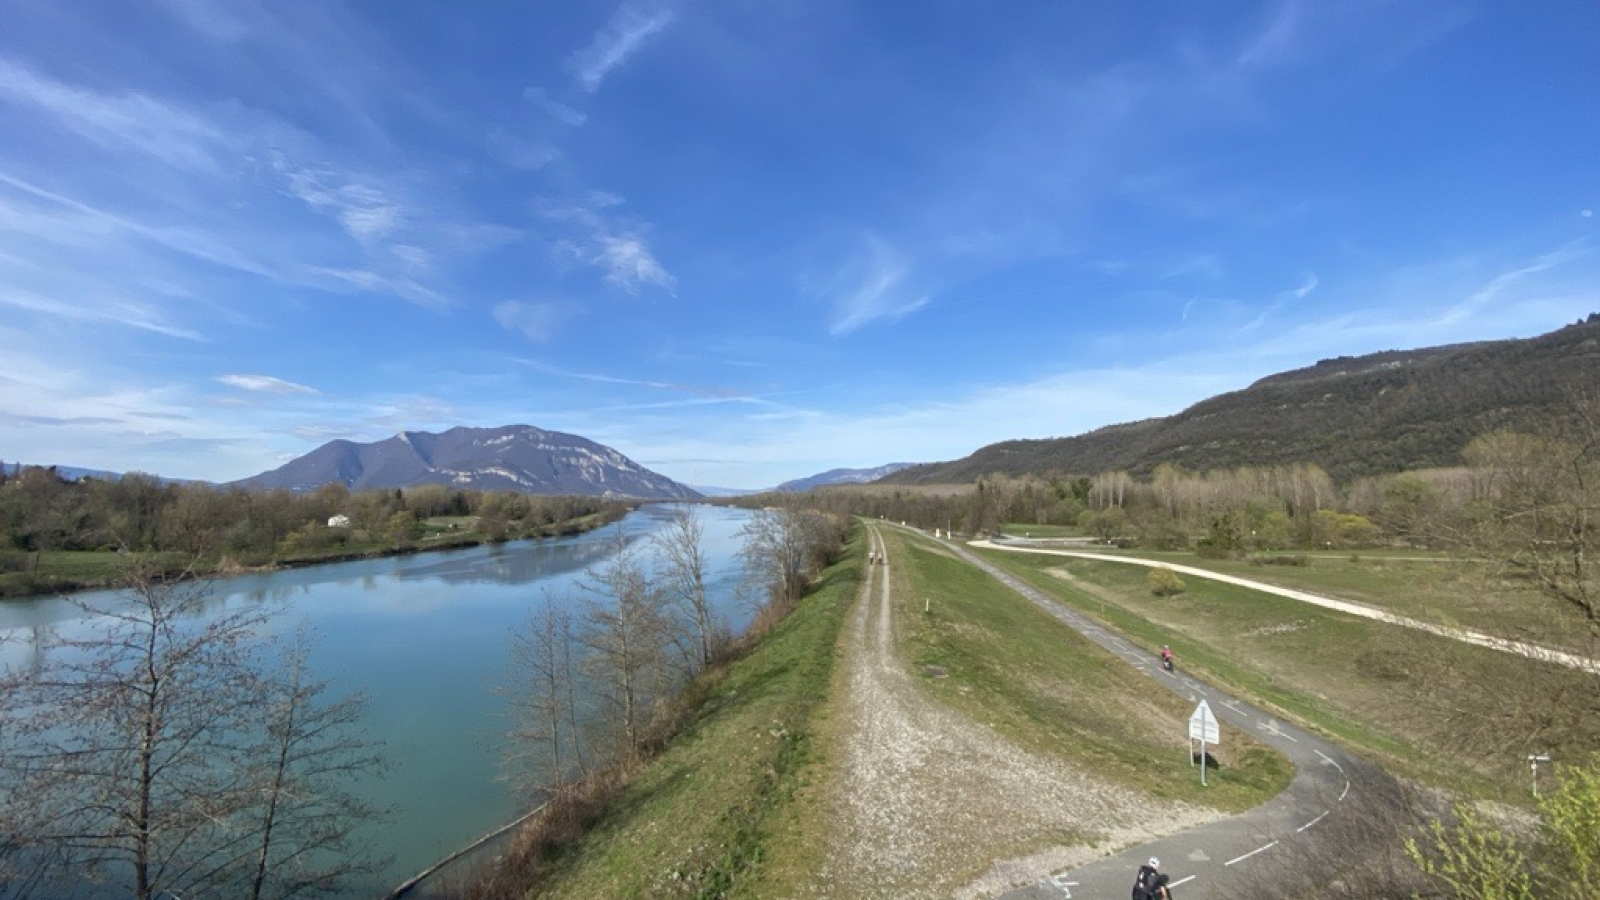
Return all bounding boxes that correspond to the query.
[814,528,1219,898]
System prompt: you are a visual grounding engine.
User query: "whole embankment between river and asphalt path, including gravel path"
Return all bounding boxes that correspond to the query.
[445,525,1291,900]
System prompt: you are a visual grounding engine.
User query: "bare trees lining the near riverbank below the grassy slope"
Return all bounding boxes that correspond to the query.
[509,504,850,793]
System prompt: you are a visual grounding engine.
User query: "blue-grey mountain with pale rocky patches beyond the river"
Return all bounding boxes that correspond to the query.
[234,424,699,500]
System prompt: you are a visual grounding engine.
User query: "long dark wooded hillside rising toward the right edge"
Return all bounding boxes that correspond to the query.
[883,314,1600,484]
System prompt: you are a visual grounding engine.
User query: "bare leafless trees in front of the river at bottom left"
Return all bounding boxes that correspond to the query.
[0,563,385,900]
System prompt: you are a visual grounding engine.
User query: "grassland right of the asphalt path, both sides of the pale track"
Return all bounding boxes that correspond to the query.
[984,534,1600,802]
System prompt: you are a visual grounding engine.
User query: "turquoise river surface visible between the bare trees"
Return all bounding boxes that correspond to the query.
[0,506,750,897]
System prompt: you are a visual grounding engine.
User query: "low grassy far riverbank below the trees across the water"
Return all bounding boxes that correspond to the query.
[0,504,638,602]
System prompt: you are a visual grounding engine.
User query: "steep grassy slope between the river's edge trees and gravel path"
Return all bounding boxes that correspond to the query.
[539,528,866,898]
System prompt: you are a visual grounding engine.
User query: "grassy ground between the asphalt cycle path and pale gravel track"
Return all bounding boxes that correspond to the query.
[986,551,1600,796]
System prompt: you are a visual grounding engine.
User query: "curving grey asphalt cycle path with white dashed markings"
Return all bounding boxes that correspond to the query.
[946,531,1366,900]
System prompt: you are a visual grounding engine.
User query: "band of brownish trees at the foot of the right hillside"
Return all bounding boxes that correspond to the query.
[811,402,1600,589]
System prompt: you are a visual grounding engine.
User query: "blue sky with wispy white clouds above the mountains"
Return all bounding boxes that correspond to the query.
[0,0,1600,487]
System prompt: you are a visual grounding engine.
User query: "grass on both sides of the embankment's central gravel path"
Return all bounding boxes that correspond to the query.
[505,530,1291,897]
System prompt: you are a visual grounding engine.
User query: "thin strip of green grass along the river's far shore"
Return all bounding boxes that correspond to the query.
[0,511,626,597]
